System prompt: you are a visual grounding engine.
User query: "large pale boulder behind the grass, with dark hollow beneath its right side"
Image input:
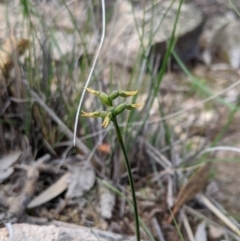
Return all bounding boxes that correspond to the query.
[102,0,203,69]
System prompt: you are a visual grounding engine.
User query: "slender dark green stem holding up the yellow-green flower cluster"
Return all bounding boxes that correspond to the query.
[112,113,140,241]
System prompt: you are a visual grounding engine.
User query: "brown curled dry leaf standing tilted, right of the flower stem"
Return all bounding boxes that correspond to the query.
[168,163,211,223]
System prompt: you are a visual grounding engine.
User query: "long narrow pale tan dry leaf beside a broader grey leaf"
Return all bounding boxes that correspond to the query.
[28,172,71,208]
